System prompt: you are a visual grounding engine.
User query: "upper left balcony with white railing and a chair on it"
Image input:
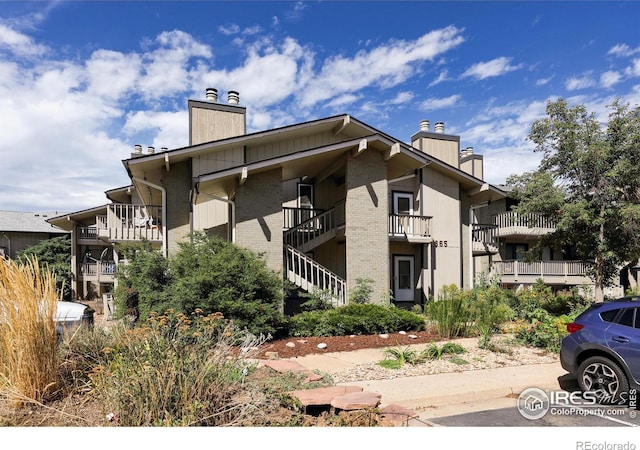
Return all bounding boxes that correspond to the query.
[96,204,163,242]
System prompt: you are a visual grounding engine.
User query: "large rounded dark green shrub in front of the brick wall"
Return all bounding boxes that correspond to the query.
[116,233,285,335]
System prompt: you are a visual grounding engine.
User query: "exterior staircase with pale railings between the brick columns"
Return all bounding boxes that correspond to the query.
[284,208,347,306]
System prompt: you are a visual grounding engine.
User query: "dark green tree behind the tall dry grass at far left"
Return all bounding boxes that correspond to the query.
[16,235,73,300]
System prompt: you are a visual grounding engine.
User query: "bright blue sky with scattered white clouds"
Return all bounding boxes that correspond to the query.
[0,0,640,212]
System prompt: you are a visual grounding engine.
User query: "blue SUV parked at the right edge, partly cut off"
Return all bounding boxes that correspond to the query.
[560,296,640,404]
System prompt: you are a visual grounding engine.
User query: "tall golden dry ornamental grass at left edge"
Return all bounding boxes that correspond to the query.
[0,258,58,406]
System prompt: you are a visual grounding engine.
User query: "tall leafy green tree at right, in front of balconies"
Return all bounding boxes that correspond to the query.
[507,99,640,301]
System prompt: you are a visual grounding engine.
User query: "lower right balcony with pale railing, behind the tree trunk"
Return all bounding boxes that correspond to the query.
[491,260,593,285]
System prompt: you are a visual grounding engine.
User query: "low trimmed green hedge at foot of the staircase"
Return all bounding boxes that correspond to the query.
[289,303,425,336]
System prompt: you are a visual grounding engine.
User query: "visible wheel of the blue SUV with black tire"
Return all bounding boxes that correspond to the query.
[578,356,629,403]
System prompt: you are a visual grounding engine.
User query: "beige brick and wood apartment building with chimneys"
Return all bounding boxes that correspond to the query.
[49,88,600,307]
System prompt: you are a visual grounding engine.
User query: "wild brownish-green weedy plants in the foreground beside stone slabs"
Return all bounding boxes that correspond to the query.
[90,311,264,426]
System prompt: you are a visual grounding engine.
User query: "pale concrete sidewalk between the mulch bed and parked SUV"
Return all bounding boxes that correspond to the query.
[292,349,566,419]
